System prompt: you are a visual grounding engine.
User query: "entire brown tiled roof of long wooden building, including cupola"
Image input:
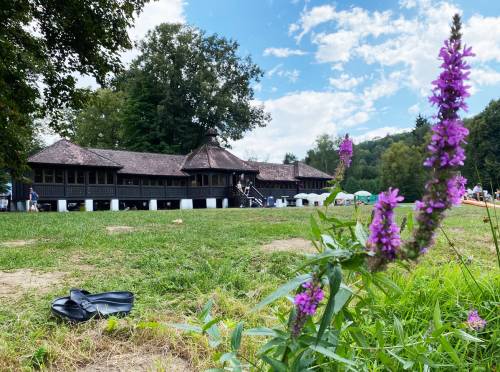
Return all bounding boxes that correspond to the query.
[28,134,332,182]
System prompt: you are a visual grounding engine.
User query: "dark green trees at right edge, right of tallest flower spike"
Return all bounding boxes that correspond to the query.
[464,99,500,188]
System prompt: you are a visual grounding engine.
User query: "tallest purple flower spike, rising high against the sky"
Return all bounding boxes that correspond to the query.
[404,23,473,259]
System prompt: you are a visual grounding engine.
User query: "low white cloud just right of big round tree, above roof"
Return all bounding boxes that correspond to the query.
[232,75,395,162]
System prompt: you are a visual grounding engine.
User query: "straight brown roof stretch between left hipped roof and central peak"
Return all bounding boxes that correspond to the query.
[89,149,187,177]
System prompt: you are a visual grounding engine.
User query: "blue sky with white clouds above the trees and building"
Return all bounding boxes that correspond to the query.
[74,0,500,162]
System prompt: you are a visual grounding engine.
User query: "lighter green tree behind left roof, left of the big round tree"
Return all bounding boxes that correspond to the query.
[72,89,125,149]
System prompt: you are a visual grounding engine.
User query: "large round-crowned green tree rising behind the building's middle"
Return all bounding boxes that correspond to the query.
[118,24,270,153]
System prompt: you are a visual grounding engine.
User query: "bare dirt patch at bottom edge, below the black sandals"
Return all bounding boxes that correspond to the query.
[79,351,191,372]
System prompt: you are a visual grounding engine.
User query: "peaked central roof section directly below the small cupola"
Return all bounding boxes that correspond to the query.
[182,143,257,172]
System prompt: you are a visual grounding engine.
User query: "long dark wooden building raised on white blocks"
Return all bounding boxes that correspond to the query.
[13,130,331,211]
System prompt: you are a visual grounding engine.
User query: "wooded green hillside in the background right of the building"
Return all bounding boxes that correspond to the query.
[304,100,500,202]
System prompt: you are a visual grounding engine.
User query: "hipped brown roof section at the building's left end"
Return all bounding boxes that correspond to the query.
[28,139,121,168]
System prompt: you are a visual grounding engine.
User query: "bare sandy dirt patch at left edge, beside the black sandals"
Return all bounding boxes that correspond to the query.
[0,269,66,298]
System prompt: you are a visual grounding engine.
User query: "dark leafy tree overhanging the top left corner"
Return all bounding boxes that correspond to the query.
[0,0,147,178]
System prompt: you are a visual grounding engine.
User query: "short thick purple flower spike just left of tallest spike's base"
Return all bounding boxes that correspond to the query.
[367,188,403,261]
